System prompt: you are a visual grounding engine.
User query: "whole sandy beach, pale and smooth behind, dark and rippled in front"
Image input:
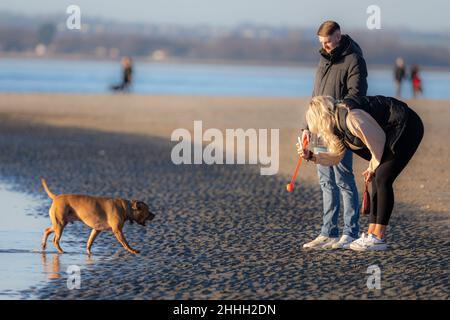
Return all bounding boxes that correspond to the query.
[0,94,450,299]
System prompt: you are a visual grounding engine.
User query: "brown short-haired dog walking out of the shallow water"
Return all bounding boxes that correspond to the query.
[41,178,155,254]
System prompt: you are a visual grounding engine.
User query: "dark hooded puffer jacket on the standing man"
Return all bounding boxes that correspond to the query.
[313,35,367,99]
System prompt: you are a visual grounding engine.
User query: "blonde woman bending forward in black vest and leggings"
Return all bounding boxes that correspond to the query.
[297,96,424,251]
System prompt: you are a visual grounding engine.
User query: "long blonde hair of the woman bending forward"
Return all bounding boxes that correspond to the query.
[306,96,345,155]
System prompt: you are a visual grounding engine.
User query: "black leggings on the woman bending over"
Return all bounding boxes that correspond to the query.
[370,110,424,225]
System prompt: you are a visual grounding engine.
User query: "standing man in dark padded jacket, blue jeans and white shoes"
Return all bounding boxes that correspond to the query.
[302,21,367,249]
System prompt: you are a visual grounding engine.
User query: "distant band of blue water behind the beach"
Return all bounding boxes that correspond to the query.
[0,59,450,99]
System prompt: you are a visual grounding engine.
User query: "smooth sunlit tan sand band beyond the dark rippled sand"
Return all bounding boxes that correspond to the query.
[0,94,450,213]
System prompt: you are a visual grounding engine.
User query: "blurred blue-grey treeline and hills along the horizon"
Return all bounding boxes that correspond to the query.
[0,11,450,67]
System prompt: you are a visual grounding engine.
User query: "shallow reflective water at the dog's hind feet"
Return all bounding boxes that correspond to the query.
[0,182,104,299]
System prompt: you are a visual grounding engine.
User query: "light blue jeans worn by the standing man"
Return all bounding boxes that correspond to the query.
[317,150,359,238]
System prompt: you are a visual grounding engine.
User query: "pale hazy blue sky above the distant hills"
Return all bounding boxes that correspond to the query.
[0,0,450,32]
